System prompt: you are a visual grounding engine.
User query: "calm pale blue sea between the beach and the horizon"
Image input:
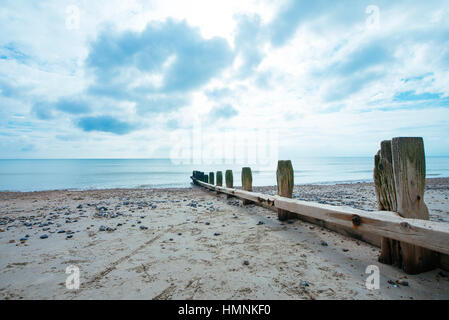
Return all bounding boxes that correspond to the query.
[0,157,449,191]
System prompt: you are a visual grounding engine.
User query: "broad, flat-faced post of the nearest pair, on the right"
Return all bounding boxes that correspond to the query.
[391,138,437,274]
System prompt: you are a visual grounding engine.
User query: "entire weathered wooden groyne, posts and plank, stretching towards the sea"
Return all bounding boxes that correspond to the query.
[191,138,449,274]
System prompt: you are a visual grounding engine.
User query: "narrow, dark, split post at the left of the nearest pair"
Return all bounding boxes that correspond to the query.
[374,140,402,268]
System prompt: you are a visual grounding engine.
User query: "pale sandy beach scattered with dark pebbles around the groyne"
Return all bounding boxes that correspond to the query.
[0,178,449,300]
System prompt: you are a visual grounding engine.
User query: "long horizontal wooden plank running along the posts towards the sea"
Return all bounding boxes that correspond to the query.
[194,179,449,254]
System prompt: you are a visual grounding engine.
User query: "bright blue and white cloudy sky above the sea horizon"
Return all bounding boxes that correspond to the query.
[0,0,449,158]
